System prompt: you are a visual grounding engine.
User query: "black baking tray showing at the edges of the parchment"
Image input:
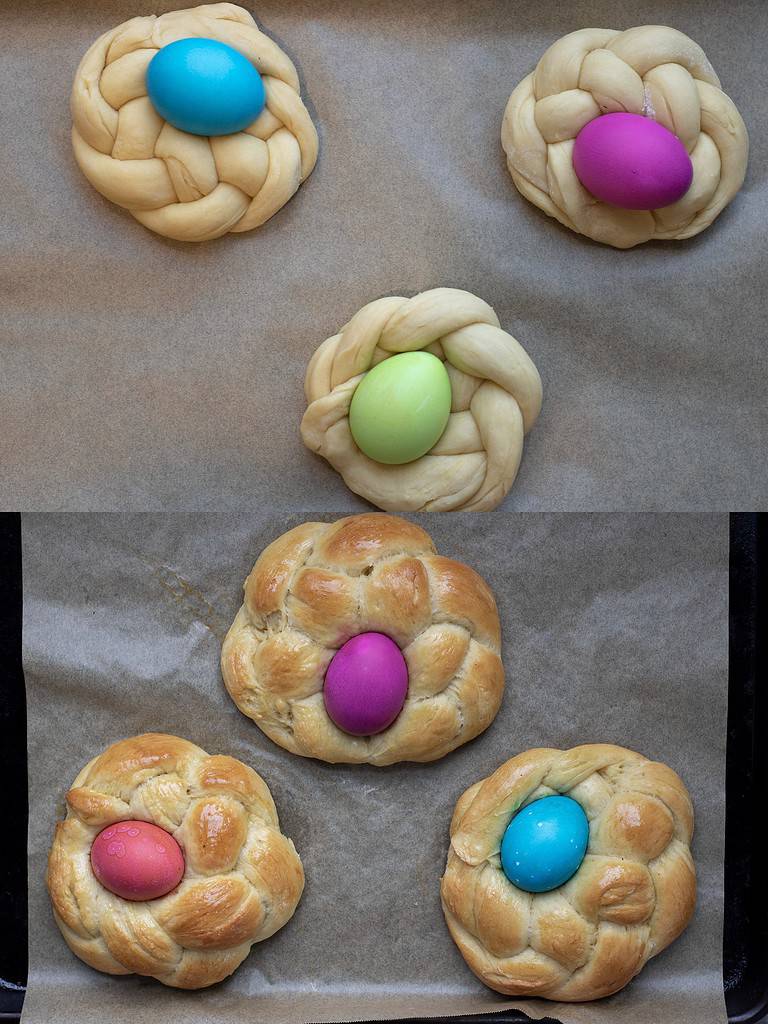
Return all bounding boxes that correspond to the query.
[0,513,768,1024]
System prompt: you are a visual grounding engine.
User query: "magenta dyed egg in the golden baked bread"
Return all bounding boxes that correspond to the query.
[323,633,408,736]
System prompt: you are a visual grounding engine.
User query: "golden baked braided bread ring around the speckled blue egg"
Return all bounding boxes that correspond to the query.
[441,743,696,1002]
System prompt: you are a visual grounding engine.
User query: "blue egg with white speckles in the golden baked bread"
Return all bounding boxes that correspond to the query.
[502,797,590,893]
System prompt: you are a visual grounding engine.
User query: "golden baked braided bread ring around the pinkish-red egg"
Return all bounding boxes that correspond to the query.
[47,733,304,988]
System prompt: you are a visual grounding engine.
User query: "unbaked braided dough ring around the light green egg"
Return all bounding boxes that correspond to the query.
[301,288,542,512]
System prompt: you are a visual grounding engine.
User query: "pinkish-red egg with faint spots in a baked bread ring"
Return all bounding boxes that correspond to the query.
[91,821,184,901]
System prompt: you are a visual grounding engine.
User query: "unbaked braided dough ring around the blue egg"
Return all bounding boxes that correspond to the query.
[71,3,317,242]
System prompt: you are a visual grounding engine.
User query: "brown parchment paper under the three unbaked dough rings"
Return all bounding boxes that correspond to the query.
[0,0,768,512]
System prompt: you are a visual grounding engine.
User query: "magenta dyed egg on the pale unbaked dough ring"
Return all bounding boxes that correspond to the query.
[573,114,693,210]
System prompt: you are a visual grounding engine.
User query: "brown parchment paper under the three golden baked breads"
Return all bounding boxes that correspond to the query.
[23,516,728,1024]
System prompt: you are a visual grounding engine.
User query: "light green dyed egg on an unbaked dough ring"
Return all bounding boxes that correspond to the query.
[349,352,451,466]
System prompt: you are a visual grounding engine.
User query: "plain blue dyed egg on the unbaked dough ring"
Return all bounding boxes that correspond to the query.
[146,39,265,135]
